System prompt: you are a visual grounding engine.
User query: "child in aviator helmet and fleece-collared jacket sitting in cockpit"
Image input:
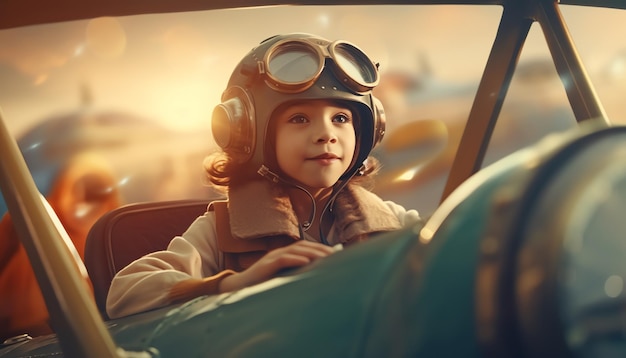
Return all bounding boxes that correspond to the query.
[107,34,419,318]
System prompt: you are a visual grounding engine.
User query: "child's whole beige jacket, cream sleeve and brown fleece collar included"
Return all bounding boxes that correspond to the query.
[107,181,419,318]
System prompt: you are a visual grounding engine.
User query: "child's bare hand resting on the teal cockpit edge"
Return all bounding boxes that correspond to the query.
[219,240,336,292]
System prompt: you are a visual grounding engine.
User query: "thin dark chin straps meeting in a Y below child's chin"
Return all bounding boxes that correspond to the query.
[257,165,363,245]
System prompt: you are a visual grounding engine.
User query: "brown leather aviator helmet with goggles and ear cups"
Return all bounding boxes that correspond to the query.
[211,33,385,179]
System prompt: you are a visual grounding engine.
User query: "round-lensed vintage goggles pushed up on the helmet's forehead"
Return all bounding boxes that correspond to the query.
[258,39,379,93]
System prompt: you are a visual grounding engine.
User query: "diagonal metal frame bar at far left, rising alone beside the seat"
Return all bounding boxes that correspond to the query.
[0,113,118,357]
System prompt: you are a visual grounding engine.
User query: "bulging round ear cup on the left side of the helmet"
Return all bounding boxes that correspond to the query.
[211,86,256,163]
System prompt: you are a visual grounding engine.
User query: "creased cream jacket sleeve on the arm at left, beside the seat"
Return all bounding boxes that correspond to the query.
[106,212,219,318]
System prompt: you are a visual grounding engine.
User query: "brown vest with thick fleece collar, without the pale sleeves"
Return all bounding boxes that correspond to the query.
[217,181,416,271]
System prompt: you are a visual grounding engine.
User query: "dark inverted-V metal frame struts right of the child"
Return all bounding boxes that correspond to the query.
[441,0,604,201]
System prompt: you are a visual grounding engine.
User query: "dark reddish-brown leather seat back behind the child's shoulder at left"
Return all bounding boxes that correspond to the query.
[85,200,209,318]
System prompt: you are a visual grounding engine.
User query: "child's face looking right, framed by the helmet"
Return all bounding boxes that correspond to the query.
[274,100,356,191]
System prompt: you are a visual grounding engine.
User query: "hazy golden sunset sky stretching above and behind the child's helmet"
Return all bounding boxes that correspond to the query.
[0,6,626,134]
